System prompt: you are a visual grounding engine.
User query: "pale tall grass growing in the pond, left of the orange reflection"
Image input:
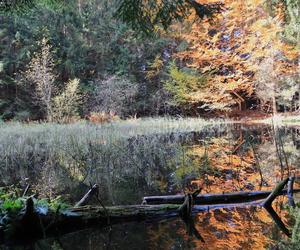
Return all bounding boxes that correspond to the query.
[0,118,223,203]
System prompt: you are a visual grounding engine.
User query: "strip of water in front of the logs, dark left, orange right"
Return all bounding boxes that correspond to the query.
[31,204,288,250]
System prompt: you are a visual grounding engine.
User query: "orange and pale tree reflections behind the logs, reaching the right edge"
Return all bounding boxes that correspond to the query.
[180,130,300,192]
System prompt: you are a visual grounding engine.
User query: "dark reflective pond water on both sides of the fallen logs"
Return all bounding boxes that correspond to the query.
[0,121,300,250]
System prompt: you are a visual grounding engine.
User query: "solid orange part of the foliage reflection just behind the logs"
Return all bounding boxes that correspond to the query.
[189,137,260,192]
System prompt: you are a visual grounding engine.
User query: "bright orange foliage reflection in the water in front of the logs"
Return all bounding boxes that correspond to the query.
[192,207,290,249]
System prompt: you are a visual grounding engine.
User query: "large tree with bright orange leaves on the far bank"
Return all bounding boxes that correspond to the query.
[168,0,299,112]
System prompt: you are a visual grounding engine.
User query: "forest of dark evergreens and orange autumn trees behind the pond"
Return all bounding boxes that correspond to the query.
[0,0,300,121]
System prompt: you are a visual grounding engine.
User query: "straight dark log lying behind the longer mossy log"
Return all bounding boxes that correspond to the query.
[143,189,300,205]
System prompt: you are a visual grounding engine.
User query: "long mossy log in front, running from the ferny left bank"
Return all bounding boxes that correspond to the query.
[9,203,259,240]
